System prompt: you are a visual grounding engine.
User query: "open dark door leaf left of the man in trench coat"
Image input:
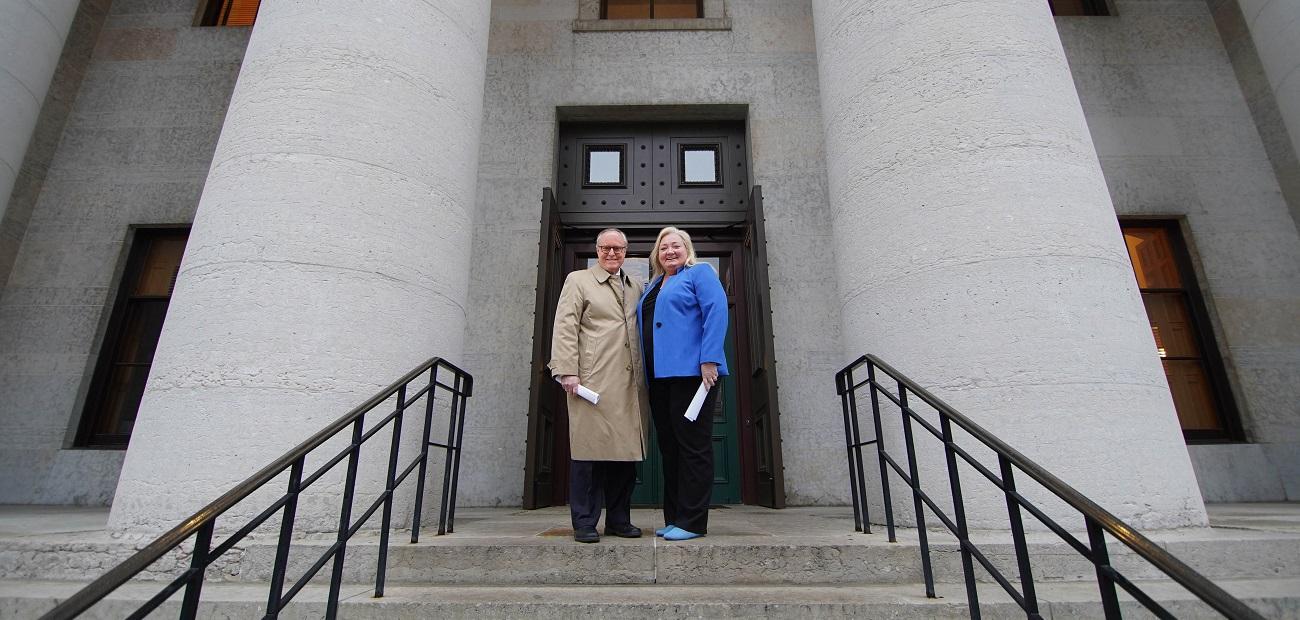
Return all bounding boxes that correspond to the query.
[524,187,568,508]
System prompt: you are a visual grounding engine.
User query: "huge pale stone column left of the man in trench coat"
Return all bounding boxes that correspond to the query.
[111,0,488,530]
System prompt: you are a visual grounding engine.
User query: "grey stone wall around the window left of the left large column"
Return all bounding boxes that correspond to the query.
[0,0,250,504]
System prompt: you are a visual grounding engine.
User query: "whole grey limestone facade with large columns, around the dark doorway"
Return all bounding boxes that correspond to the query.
[0,0,1300,526]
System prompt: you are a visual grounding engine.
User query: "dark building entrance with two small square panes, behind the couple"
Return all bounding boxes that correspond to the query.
[524,122,785,508]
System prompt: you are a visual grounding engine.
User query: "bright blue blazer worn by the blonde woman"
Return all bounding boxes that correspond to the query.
[637,263,727,378]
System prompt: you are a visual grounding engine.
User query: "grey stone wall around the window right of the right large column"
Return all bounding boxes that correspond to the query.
[1057,0,1300,500]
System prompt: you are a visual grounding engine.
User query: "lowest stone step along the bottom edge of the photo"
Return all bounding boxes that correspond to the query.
[0,578,1300,620]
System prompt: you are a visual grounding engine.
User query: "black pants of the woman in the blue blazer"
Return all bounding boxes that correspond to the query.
[650,377,719,534]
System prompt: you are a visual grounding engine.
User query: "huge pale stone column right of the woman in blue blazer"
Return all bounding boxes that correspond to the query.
[813,0,1205,528]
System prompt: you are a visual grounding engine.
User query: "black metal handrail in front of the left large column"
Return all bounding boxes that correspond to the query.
[42,357,473,619]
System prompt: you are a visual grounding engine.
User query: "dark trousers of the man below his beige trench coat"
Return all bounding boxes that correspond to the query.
[569,460,637,529]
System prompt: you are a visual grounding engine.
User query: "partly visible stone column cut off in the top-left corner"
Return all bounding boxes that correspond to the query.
[0,0,78,253]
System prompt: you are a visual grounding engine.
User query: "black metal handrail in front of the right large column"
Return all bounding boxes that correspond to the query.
[835,355,1262,620]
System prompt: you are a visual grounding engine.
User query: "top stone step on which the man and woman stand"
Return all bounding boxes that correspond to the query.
[0,508,1300,586]
